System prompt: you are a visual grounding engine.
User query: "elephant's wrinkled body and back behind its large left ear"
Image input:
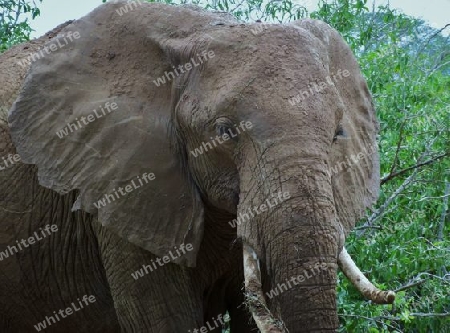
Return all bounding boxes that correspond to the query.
[0,22,120,333]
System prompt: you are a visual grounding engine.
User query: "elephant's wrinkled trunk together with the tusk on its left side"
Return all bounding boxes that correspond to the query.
[238,158,343,333]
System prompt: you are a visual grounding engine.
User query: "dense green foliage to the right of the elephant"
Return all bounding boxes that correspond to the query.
[323,1,450,332]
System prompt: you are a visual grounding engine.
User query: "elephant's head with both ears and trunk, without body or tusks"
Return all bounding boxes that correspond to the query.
[9,2,379,332]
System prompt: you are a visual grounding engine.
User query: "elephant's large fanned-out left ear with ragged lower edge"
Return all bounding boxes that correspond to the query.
[9,1,236,266]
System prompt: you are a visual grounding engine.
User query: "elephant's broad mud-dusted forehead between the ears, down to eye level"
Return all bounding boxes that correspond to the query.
[179,25,342,140]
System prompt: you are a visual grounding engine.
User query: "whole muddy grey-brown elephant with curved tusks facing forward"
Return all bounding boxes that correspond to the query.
[0,1,393,333]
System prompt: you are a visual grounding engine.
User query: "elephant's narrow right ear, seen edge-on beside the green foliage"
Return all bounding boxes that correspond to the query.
[294,20,380,236]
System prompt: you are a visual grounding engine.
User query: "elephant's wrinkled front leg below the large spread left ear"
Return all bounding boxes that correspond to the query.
[96,224,203,333]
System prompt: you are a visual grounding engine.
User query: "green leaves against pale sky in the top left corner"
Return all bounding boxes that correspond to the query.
[0,0,42,53]
